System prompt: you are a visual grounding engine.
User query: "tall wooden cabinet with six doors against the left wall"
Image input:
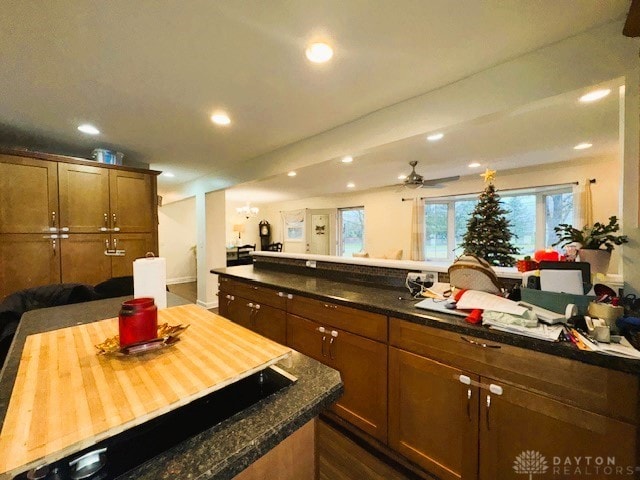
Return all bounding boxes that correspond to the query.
[0,152,159,296]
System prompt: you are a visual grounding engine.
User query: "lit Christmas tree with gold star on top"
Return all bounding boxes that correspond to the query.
[460,169,519,267]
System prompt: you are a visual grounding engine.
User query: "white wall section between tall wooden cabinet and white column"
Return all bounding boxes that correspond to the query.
[158,197,196,284]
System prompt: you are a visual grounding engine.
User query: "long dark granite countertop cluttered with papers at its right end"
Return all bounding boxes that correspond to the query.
[211,265,640,375]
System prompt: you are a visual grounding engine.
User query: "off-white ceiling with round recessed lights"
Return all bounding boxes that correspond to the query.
[0,0,637,201]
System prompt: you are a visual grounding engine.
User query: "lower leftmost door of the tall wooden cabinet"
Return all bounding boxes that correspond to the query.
[0,234,60,299]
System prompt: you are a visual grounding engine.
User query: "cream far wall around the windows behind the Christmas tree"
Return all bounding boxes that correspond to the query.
[254,158,621,273]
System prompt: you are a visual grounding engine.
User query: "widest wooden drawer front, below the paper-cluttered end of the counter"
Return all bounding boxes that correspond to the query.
[389,318,640,422]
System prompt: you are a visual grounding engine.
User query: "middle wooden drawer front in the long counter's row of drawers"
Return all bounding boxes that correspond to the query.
[287,295,387,342]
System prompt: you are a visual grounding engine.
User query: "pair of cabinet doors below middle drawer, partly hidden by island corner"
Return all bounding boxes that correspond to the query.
[287,314,387,443]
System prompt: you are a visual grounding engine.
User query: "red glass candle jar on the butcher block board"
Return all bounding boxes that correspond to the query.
[118,297,158,347]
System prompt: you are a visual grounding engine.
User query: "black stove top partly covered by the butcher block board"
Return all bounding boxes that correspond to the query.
[14,368,295,480]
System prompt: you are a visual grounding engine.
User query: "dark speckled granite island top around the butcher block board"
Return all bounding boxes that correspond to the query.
[0,293,343,480]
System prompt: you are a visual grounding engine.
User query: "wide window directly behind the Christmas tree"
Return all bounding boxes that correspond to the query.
[424,186,574,261]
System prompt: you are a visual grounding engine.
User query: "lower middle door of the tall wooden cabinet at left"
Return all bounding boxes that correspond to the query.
[60,233,112,285]
